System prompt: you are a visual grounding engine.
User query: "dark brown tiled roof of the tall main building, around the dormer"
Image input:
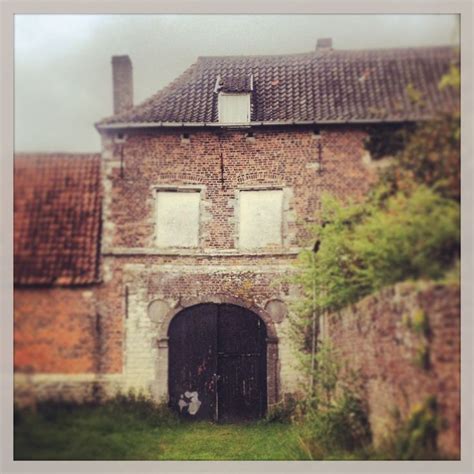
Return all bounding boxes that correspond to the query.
[97,46,459,128]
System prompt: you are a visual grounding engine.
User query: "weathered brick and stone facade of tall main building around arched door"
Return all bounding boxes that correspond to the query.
[96,126,374,401]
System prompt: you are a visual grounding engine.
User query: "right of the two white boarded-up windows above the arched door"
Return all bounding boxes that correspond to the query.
[239,190,283,248]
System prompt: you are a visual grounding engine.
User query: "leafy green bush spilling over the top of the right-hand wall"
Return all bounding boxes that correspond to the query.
[295,186,460,318]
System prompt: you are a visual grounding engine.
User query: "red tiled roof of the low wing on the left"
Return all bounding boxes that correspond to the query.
[14,154,101,285]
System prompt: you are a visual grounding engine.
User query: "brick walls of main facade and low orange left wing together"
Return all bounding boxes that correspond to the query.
[15,126,374,408]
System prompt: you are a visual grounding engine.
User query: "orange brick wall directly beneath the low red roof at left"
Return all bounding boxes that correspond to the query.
[14,288,99,374]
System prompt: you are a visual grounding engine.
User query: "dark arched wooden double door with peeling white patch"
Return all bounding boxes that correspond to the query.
[168,303,267,421]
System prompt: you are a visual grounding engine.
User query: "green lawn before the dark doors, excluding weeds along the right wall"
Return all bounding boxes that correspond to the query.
[15,406,307,460]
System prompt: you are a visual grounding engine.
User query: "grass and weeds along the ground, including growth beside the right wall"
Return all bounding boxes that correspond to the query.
[14,396,446,461]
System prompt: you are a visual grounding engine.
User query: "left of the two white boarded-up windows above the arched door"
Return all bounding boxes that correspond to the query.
[156,191,200,247]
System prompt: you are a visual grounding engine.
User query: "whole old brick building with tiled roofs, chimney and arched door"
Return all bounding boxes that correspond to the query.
[15,40,457,418]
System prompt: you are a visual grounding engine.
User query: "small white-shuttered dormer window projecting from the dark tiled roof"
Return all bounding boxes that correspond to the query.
[215,75,253,124]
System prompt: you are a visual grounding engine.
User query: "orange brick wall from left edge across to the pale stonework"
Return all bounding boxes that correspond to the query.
[14,285,123,374]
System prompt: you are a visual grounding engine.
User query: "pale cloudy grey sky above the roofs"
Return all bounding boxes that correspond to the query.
[15,14,459,152]
